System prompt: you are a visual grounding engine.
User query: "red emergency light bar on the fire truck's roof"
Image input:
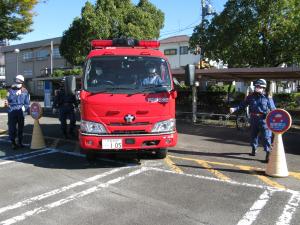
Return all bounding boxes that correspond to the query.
[91,38,160,48]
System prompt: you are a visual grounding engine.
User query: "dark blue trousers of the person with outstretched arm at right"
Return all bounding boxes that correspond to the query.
[250,116,272,152]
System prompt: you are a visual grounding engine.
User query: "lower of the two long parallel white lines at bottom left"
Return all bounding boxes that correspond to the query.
[0,167,148,225]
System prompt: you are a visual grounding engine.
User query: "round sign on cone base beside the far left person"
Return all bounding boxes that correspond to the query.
[30,102,46,150]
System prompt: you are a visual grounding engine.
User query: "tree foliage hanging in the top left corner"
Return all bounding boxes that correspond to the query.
[0,0,38,40]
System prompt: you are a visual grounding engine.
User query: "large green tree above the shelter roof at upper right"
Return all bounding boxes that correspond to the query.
[190,0,300,67]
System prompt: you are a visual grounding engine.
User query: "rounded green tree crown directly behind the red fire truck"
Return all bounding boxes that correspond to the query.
[60,0,164,65]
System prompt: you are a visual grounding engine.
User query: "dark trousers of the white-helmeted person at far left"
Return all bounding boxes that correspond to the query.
[8,109,24,143]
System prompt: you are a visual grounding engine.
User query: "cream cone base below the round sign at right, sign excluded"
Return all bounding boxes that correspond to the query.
[266,134,289,177]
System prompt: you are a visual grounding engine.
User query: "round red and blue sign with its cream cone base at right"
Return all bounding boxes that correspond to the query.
[266,109,292,177]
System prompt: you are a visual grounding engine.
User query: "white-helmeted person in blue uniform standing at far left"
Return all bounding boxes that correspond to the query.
[7,75,30,149]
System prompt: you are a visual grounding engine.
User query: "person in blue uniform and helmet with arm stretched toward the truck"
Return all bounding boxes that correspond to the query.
[230,79,276,162]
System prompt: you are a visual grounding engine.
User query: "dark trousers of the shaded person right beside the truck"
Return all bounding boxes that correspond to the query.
[59,108,76,134]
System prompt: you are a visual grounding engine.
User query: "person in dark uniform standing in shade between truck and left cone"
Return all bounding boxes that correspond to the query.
[53,79,78,138]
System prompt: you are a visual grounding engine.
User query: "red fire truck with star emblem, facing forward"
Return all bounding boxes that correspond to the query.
[79,39,177,159]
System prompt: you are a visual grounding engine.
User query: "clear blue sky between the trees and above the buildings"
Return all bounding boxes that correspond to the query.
[10,0,226,44]
